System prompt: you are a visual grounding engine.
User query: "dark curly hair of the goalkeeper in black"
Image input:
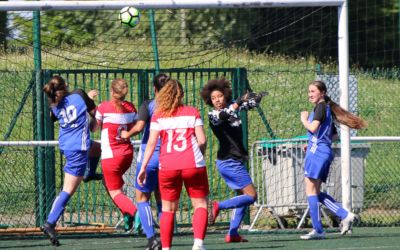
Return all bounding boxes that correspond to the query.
[200,78,232,107]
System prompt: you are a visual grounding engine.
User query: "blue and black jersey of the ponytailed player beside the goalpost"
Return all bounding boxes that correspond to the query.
[307,102,335,153]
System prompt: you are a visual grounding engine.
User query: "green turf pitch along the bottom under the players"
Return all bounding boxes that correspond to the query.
[0,227,400,250]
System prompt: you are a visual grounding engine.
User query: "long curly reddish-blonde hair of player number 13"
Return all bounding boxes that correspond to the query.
[155,79,183,117]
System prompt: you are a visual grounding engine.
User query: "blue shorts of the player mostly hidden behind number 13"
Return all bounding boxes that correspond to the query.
[135,154,158,193]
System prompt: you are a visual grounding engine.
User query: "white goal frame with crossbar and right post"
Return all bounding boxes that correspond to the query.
[0,0,351,210]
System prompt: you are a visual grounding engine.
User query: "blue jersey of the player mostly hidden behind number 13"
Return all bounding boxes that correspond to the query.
[137,100,161,163]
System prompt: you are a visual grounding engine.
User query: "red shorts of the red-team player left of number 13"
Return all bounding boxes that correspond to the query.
[101,154,133,191]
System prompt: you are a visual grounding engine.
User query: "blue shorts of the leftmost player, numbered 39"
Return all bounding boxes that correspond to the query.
[62,150,89,177]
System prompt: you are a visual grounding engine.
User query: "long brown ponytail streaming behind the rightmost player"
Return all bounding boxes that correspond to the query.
[310,81,368,129]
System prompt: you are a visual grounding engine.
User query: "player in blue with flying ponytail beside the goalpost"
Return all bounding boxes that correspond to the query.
[300,81,366,240]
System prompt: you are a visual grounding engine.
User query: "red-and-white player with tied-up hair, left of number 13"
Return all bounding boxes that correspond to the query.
[96,78,137,223]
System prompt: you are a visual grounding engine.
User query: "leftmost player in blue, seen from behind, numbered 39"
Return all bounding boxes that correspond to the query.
[42,76,96,246]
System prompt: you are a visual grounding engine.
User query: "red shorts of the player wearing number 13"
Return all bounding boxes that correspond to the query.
[158,167,209,201]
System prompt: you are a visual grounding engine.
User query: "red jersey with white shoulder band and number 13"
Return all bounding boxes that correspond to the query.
[150,106,206,170]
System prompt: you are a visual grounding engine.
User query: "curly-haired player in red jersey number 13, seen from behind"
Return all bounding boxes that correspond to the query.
[137,80,209,250]
